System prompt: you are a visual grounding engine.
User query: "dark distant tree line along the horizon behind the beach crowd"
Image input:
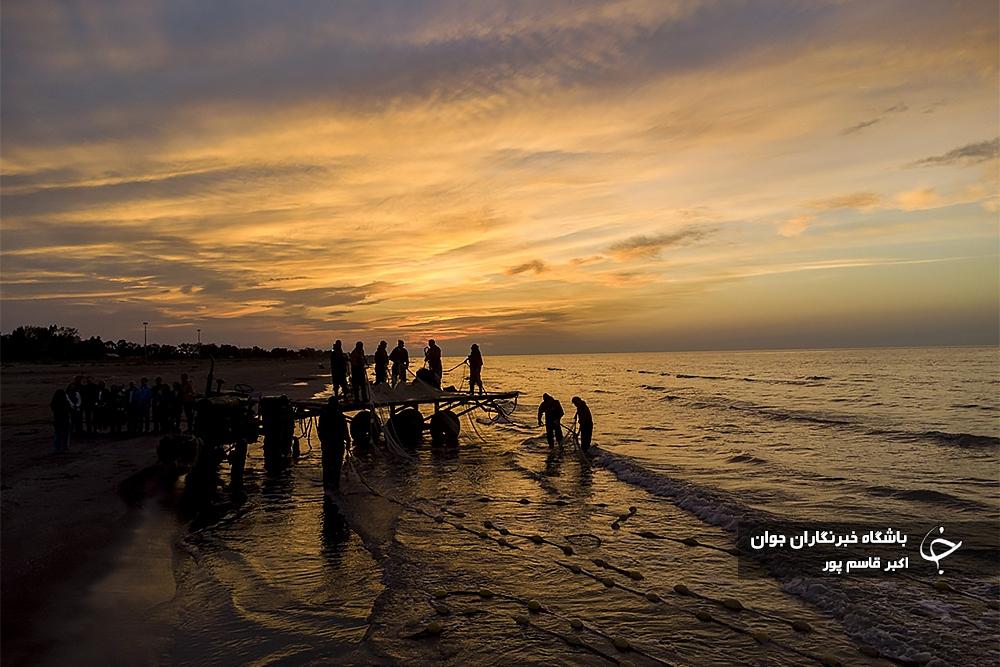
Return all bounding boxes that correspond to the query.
[0,324,325,361]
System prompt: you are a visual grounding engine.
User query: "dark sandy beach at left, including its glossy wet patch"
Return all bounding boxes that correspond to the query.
[0,359,321,665]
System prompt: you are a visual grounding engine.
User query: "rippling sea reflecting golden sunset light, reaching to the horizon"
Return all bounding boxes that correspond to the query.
[113,346,1000,665]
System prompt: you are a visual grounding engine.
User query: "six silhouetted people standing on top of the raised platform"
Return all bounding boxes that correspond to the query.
[330,338,486,403]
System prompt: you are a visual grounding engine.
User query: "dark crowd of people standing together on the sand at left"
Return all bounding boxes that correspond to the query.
[49,373,196,452]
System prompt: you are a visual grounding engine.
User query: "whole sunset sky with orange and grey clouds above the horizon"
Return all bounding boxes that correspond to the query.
[0,0,1000,354]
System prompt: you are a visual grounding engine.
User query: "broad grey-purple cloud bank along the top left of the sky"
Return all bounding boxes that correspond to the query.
[0,0,864,144]
